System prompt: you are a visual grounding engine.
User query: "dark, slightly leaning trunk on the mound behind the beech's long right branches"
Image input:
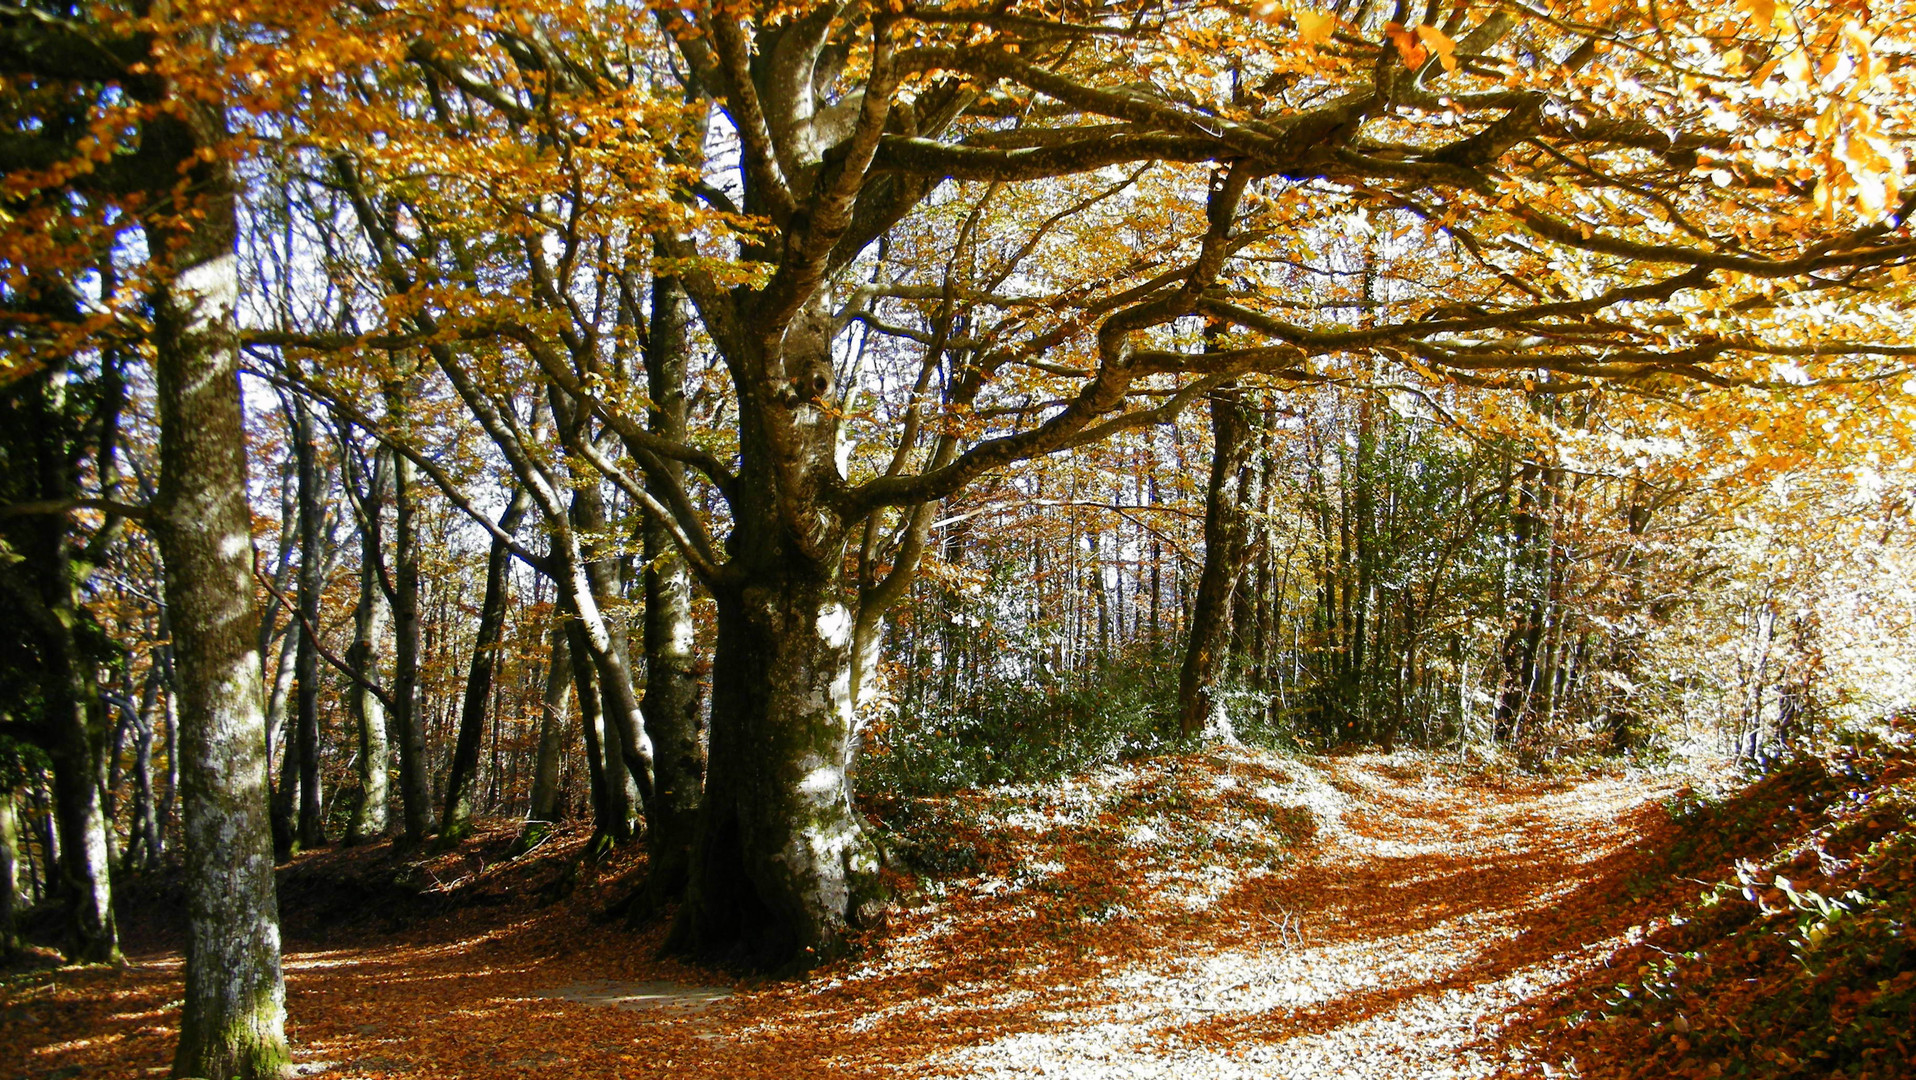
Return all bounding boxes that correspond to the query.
[1178,387,1251,739]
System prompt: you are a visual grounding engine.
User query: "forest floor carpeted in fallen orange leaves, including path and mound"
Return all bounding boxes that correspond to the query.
[0,749,1709,1080]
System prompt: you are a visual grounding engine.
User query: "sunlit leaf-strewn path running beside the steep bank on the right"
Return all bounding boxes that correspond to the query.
[919,758,1665,1080]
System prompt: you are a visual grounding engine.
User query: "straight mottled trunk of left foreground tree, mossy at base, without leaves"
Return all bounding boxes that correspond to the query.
[146,105,287,1080]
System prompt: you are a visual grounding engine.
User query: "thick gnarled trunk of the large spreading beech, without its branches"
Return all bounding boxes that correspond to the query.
[667,301,885,971]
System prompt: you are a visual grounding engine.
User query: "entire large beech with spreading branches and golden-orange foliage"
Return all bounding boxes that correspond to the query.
[231,0,1916,969]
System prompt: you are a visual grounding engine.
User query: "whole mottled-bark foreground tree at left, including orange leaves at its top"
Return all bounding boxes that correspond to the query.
[0,0,287,1080]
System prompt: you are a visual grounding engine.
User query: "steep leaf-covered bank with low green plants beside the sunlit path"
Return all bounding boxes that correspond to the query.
[1562,724,1916,1080]
